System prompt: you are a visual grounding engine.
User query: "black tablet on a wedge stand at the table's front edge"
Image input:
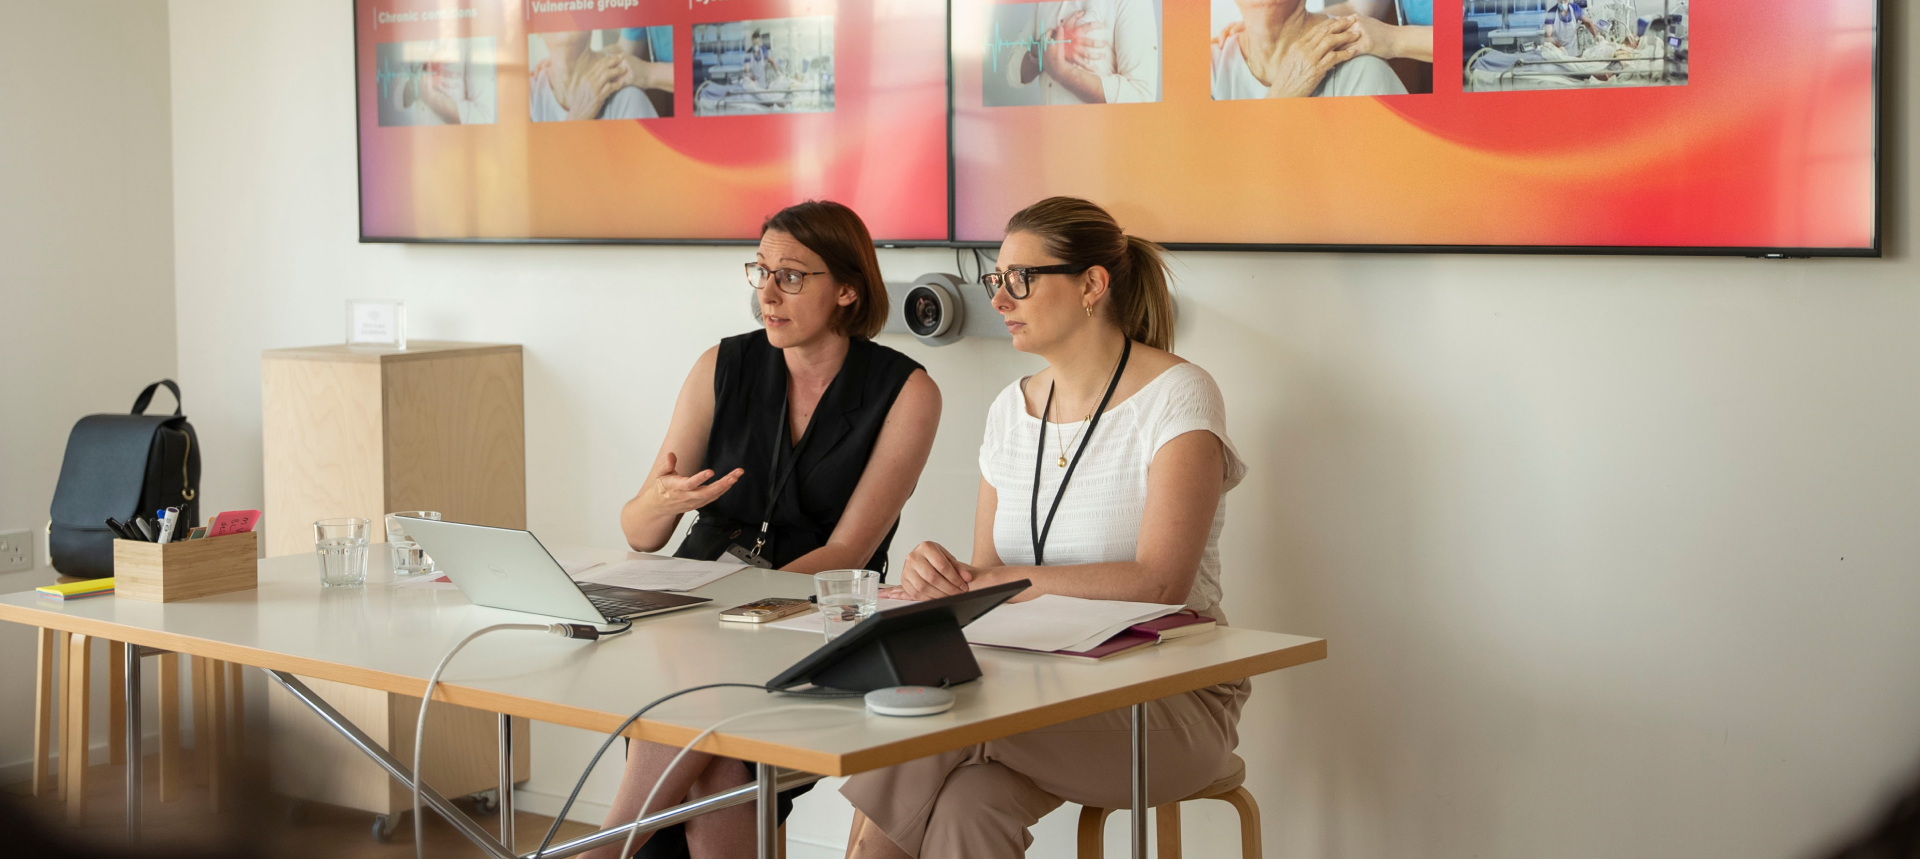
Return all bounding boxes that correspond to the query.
[766,578,1031,692]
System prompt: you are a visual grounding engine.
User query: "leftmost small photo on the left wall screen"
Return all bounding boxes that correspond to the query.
[374,37,499,125]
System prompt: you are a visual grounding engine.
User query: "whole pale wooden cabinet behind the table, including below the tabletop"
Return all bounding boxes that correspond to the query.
[261,340,528,815]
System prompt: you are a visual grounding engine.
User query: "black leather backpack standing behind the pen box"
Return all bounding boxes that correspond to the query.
[46,379,200,578]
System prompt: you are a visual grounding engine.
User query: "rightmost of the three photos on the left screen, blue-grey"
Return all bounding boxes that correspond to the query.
[693,15,833,117]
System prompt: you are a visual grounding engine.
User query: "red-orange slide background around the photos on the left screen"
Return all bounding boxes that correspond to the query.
[353,0,948,240]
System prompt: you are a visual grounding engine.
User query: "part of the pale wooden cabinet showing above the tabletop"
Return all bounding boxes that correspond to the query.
[261,340,526,555]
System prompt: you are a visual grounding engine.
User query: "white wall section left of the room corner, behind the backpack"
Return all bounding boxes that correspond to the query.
[0,0,178,780]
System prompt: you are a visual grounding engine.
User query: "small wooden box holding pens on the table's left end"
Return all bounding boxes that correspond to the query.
[113,530,259,603]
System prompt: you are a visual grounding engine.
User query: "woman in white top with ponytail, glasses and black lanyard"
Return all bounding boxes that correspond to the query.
[841,198,1248,859]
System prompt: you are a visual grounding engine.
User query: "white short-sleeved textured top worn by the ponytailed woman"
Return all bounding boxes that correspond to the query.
[979,363,1246,609]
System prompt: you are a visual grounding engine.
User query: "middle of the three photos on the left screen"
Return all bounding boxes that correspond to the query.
[526,27,674,123]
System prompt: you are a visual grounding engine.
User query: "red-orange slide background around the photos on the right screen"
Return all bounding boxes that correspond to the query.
[952,0,1876,252]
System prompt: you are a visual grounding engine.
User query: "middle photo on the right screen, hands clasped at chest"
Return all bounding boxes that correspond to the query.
[1210,0,1434,102]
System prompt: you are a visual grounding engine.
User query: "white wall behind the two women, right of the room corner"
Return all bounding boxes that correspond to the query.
[171,0,1920,859]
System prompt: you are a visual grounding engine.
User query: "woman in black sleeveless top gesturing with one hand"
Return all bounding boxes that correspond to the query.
[589,202,941,859]
